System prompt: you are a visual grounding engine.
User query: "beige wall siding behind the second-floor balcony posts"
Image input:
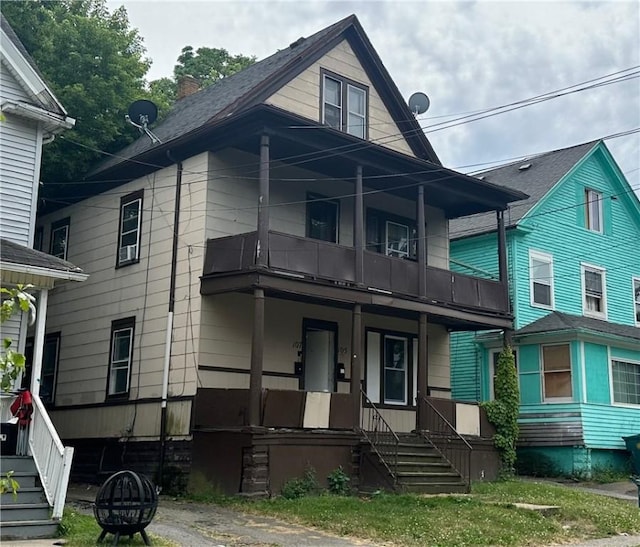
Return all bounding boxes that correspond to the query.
[208,150,449,269]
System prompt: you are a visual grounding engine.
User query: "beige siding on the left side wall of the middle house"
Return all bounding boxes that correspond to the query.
[40,153,208,437]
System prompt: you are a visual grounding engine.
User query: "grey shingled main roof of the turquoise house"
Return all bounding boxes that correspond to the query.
[449,141,599,239]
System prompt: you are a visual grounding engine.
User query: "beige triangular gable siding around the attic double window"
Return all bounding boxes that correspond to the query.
[265,40,414,156]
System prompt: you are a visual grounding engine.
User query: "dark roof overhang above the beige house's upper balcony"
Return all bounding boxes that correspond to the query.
[74,104,527,218]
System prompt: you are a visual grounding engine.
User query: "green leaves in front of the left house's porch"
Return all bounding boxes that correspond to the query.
[0,285,36,393]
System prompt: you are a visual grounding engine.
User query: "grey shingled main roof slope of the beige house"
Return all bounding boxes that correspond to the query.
[90,15,355,176]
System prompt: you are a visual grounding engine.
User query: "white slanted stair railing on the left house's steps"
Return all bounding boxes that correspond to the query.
[29,394,73,519]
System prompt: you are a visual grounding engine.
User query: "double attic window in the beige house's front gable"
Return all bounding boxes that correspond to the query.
[321,71,368,139]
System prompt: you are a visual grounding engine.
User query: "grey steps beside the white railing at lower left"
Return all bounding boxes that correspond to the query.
[0,456,58,541]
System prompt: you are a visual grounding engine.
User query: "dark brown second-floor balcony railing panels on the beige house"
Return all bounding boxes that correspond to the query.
[202,231,511,329]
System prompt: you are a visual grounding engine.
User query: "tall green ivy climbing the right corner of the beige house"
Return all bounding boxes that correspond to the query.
[483,347,520,476]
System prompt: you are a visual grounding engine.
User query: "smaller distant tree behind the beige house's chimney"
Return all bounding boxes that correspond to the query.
[149,46,256,117]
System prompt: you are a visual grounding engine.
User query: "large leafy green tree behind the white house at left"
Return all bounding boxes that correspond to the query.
[2,0,150,187]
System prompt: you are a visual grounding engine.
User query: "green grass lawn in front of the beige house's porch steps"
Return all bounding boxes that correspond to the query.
[232,480,640,547]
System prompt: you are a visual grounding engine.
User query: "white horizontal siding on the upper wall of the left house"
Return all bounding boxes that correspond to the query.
[0,63,42,246]
